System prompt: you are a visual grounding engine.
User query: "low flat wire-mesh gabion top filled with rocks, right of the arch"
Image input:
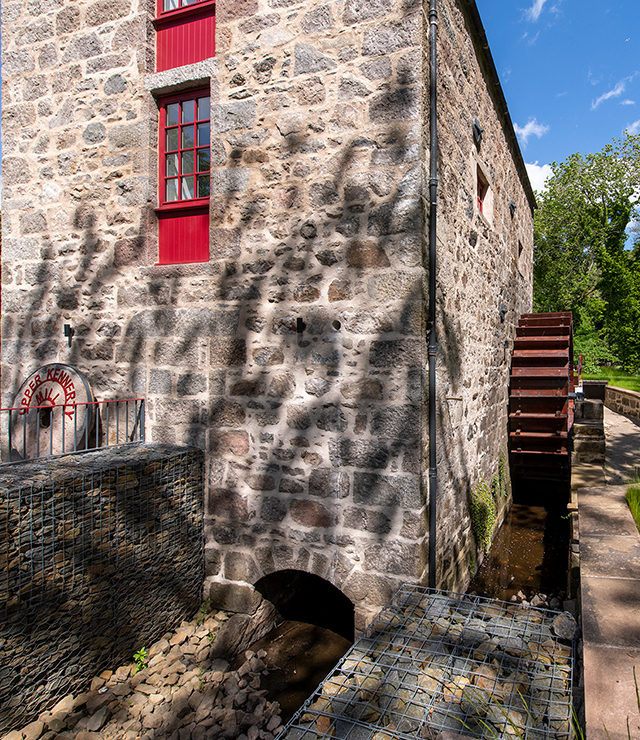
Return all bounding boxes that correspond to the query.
[278,585,573,740]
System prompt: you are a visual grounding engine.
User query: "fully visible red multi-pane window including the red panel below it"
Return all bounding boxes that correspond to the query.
[156,87,211,264]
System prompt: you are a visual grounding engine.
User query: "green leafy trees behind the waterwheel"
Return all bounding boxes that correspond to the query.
[534,134,640,370]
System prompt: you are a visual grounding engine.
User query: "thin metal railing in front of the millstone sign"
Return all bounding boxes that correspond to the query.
[0,398,145,462]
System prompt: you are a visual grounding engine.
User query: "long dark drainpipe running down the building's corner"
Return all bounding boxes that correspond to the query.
[428,0,438,588]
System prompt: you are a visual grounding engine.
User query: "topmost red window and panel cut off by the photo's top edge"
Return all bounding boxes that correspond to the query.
[153,0,216,72]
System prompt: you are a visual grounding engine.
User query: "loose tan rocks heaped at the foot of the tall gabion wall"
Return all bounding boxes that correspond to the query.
[2,612,281,740]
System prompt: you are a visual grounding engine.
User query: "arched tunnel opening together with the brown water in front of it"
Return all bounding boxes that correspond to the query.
[249,570,355,722]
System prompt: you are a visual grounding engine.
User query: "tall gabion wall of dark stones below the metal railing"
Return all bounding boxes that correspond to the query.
[0,445,203,732]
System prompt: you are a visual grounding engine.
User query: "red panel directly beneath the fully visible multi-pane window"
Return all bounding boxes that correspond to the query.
[158,206,209,265]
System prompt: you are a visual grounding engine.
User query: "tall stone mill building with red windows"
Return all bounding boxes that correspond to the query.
[2,0,535,627]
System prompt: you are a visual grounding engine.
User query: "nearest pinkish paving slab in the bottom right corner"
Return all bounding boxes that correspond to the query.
[584,645,640,740]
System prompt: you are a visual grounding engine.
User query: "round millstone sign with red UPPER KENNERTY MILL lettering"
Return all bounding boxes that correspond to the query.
[9,363,97,460]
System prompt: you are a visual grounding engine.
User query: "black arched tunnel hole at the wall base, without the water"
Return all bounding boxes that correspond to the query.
[255,570,355,642]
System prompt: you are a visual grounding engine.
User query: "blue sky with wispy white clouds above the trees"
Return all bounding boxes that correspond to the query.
[476,0,640,189]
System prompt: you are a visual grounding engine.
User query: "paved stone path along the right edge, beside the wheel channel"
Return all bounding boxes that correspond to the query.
[578,409,640,740]
